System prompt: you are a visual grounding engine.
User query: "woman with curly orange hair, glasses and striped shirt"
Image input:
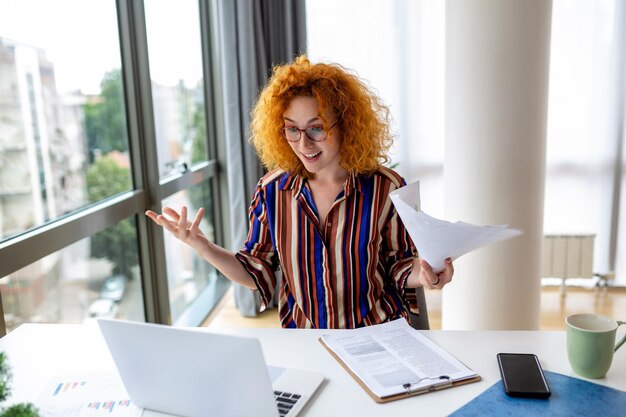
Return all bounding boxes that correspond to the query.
[146,56,454,328]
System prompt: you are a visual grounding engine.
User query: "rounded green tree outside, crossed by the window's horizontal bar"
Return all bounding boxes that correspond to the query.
[87,155,137,278]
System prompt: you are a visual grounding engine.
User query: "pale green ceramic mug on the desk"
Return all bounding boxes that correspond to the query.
[565,314,626,378]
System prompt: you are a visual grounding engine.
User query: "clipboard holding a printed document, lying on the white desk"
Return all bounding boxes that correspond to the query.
[320,319,479,399]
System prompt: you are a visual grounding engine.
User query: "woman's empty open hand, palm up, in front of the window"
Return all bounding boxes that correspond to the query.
[146,206,209,251]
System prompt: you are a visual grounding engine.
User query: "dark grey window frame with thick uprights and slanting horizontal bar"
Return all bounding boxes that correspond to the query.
[0,0,228,337]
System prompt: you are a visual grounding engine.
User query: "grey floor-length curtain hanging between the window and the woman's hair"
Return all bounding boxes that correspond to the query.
[211,0,306,316]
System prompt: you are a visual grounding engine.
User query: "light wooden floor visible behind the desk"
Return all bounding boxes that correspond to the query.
[203,287,626,330]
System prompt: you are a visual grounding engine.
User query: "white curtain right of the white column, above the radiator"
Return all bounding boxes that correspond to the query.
[544,0,626,286]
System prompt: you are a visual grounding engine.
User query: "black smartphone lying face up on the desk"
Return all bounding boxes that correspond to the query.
[497,353,551,398]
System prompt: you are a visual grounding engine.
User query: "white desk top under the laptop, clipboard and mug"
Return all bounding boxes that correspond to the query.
[0,324,626,417]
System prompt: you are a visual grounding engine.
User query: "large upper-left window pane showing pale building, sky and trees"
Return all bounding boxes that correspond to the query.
[0,0,132,241]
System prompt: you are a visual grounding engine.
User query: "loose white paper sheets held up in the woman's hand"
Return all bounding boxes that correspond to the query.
[389,181,522,272]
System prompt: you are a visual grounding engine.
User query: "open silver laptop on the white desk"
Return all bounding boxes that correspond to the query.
[97,318,324,417]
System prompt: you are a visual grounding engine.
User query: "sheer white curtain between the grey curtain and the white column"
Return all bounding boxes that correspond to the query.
[307,0,445,216]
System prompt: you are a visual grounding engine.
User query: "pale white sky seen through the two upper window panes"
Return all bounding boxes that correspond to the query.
[0,0,202,94]
